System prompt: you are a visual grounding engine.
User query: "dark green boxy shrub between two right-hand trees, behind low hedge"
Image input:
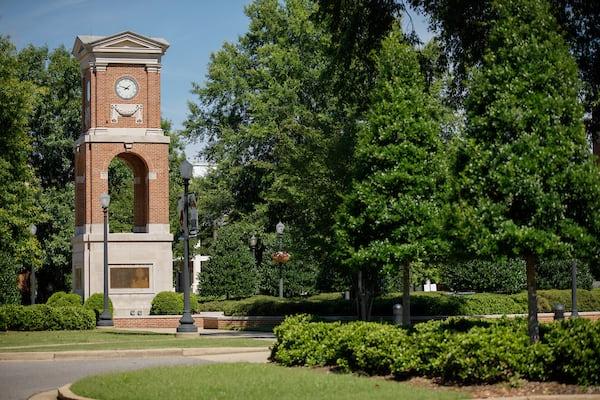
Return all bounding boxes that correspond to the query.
[440,259,526,293]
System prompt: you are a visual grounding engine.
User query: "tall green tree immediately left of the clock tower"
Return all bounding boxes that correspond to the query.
[17,45,81,301]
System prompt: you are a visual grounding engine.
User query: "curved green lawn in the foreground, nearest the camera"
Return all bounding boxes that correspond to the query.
[71,363,468,400]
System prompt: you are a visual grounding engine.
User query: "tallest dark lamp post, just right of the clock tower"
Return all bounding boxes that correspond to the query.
[177,160,198,333]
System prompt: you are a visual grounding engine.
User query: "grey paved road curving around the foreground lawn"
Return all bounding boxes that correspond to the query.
[0,353,268,400]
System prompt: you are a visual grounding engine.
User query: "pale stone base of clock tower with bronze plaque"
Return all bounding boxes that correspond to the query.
[72,226,174,317]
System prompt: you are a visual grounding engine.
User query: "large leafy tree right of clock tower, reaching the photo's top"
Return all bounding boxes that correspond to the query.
[186,0,348,290]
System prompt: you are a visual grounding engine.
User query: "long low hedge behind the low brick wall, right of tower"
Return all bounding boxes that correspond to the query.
[198,289,600,316]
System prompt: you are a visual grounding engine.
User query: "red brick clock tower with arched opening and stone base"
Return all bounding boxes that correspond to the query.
[73,32,173,316]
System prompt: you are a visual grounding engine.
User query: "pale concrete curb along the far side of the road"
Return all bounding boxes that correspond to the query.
[0,347,269,361]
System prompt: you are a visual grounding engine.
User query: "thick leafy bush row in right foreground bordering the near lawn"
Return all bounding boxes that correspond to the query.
[271,315,600,385]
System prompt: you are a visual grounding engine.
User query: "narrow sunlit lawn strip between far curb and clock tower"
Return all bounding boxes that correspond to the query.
[0,330,272,352]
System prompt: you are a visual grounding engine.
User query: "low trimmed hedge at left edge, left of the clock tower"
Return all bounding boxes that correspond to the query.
[0,304,96,331]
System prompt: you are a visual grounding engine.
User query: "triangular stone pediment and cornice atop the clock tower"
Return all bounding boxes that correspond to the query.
[72,31,169,64]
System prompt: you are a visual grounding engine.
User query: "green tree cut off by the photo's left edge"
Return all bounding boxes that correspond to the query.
[0,37,42,304]
